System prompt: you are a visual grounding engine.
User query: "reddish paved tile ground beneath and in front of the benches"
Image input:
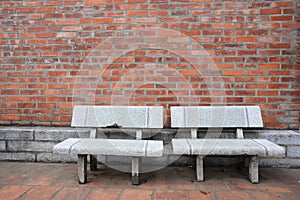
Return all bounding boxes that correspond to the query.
[0,162,300,200]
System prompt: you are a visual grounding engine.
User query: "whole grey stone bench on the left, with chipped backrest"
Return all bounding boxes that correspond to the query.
[53,106,163,185]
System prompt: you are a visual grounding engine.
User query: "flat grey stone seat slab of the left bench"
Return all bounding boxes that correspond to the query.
[53,138,163,157]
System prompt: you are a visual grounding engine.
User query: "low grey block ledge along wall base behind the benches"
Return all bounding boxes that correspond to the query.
[0,126,300,167]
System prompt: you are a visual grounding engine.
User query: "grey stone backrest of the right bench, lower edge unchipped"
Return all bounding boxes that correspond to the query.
[171,106,263,128]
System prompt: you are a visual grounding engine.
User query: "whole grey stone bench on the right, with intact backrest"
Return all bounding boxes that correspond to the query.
[171,106,285,183]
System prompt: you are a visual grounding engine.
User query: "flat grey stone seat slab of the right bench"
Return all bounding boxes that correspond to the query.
[172,139,285,157]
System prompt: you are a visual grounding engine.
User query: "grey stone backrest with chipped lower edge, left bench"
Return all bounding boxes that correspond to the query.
[71,106,163,128]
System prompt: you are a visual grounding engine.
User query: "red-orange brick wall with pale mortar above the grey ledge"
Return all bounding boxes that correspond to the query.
[0,0,300,129]
